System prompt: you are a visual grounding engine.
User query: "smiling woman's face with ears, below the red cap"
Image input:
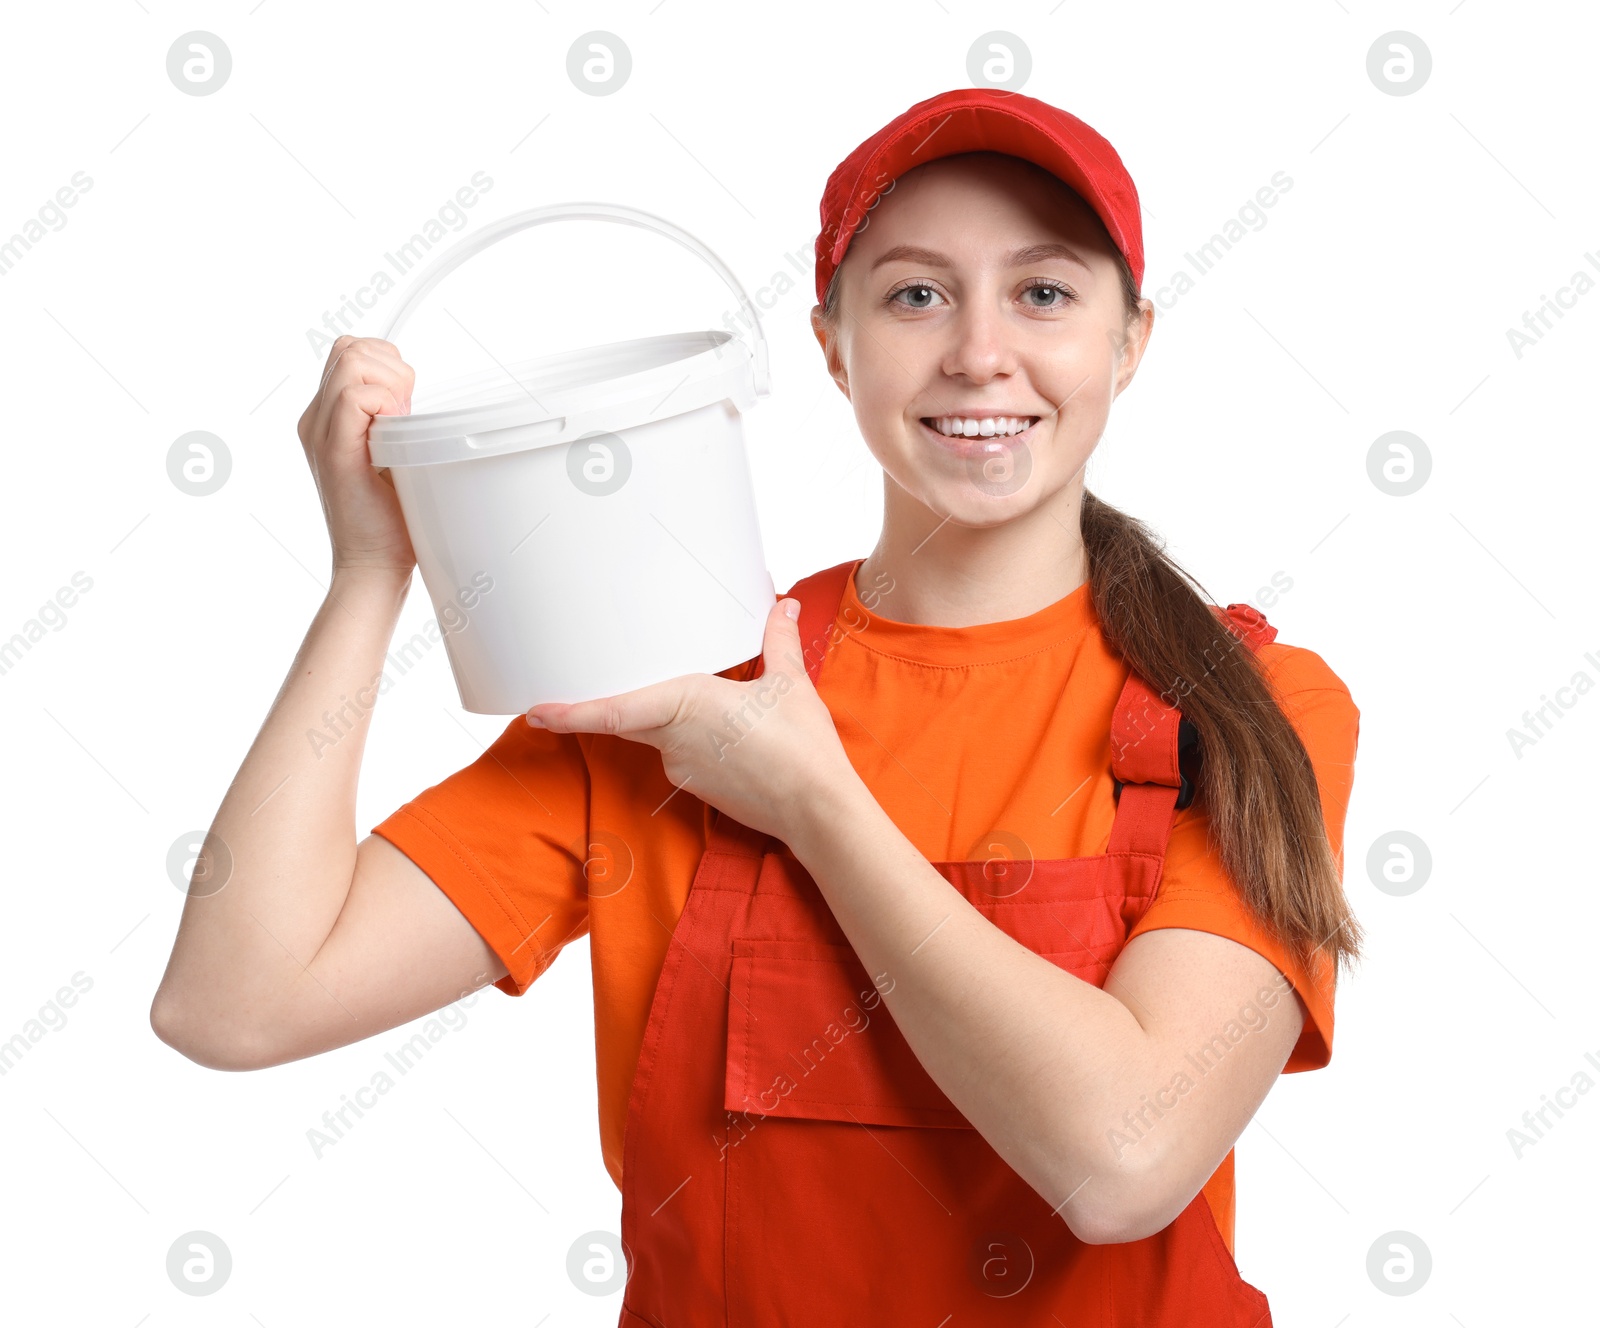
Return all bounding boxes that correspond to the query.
[811,152,1155,530]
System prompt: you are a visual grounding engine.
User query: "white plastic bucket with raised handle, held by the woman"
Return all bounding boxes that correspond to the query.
[368,203,776,715]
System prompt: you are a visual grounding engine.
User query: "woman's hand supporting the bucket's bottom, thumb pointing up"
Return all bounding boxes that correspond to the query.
[526,598,856,843]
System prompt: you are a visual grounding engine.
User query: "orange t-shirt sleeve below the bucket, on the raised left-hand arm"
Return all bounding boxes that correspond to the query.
[371,715,589,995]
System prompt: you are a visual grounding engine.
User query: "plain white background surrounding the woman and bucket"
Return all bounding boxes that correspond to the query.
[0,0,1600,1328]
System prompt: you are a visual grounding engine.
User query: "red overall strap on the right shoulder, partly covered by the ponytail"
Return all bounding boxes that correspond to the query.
[1107,603,1278,858]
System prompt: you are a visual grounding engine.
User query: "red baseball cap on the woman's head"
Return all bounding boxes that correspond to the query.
[816,88,1144,304]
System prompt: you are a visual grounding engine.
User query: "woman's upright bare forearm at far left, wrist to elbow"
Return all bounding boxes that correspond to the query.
[152,570,410,1051]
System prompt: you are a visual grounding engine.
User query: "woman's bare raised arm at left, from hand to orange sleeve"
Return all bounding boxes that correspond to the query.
[150,338,506,1069]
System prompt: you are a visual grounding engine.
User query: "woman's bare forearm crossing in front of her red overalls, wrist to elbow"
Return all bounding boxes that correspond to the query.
[789,771,1155,1238]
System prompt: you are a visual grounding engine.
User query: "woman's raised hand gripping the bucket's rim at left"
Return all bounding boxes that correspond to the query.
[299,336,416,573]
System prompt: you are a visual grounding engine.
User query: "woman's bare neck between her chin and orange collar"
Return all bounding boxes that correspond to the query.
[856,472,1088,627]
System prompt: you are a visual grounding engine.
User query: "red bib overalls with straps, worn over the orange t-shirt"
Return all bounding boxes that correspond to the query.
[621,562,1277,1328]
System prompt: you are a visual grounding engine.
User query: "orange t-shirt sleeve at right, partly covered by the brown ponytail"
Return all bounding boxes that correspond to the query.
[1128,643,1360,1074]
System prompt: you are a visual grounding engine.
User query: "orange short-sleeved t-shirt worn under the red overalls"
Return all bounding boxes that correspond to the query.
[373,560,1360,1250]
